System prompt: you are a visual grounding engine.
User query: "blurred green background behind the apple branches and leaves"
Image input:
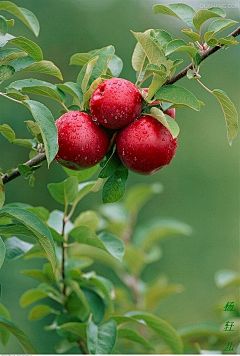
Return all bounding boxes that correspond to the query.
[0,0,240,354]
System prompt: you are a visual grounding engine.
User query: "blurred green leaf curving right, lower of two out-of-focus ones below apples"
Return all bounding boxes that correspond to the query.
[133,219,192,249]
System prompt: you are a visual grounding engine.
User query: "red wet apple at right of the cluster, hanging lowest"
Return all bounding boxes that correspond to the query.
[116,115,177,174]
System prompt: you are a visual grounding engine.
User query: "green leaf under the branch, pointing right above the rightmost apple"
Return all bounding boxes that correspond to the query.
[155,85,200,111]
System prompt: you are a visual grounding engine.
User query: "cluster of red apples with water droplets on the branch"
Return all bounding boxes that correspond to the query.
[55,78,177,174]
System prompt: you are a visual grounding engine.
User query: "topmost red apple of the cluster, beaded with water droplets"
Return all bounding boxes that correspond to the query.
[89,78,142,129]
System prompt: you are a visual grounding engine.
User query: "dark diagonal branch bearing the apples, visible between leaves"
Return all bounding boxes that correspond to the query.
[2,26,240,184]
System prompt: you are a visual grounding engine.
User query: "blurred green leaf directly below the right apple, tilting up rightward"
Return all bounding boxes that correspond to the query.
[123,183,163,213]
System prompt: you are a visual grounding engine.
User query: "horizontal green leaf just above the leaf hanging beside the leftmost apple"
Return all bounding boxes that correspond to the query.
[7,79,65,102]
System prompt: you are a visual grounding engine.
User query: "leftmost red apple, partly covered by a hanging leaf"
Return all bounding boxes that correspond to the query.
[55,111,109,170]
